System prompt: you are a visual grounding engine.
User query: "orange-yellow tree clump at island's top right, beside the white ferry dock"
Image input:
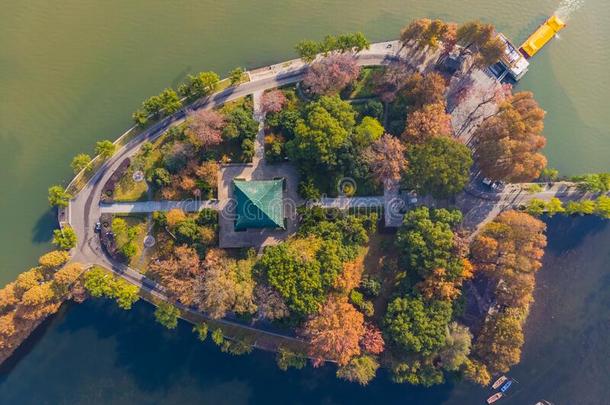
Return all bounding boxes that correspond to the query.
[456,21,506,68]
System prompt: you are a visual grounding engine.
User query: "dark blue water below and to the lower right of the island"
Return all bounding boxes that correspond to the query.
[0,218,610,405]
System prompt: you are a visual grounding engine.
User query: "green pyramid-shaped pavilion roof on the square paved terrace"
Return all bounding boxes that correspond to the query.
[233,179,284,231]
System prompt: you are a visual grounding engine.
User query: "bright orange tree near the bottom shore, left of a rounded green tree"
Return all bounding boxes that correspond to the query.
[304,296,364,366]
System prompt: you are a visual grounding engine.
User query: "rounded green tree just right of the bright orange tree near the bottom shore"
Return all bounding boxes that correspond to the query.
[384,297,452,356]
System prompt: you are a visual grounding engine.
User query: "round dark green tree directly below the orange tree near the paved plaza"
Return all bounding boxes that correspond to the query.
[404,137,472,198]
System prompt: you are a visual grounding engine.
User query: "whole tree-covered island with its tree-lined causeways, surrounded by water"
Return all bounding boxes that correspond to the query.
[0,19,610,395]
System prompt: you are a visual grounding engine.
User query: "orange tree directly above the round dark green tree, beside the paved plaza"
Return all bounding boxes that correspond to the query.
[402,103,453,143]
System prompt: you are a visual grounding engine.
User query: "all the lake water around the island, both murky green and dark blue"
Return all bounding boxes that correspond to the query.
[0,0,610,403]
